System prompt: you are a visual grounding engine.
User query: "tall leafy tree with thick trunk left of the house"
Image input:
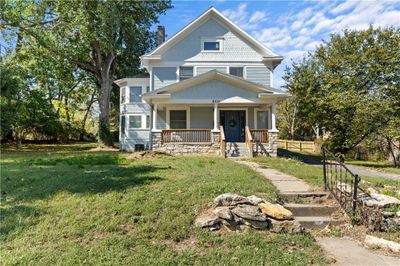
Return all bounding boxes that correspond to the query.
[1,0,171,145]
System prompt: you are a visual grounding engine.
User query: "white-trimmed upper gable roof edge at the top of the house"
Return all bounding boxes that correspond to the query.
[141,7,283,62]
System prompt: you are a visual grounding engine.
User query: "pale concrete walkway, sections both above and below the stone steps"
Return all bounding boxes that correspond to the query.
[237,161,400,266]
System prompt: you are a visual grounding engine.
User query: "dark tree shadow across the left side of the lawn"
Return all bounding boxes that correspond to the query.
[2,154,169,205]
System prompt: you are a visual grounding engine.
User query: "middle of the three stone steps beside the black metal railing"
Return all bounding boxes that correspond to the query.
[284,203,338,216]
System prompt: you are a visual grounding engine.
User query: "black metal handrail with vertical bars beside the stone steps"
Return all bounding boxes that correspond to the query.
[321,147,368,221]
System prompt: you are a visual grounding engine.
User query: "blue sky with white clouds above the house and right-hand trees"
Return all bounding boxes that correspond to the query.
[156,0,400,88]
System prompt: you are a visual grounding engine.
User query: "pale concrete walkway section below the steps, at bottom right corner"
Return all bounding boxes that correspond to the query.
[317,237,400,266]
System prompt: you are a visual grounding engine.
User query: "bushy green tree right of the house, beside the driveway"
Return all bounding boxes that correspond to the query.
[285,27,400,156]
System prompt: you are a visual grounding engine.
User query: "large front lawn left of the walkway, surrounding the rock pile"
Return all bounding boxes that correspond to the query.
[0,149,326,265]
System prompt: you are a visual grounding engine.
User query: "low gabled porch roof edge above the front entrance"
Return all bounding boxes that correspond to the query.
[142,70,290,99]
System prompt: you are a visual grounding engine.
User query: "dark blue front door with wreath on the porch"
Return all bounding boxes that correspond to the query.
[220,111,245,142]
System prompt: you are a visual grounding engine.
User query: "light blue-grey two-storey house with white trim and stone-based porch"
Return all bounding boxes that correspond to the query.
[115,8,289,156]
